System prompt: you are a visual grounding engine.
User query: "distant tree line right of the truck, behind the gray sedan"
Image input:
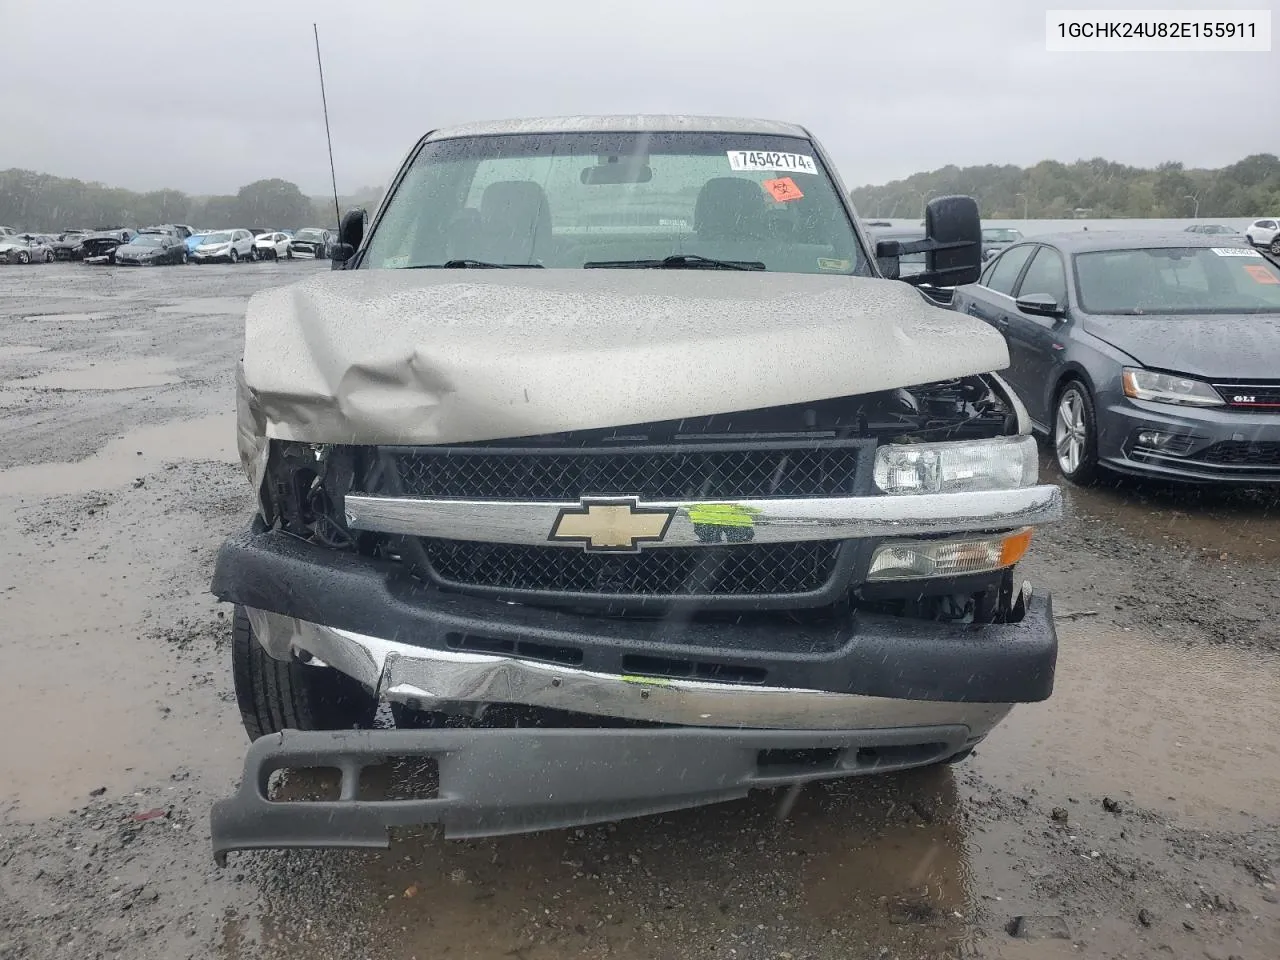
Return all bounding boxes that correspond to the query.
[850,154,1280,220]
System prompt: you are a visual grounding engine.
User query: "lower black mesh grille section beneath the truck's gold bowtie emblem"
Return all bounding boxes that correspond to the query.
[421,538,840,596]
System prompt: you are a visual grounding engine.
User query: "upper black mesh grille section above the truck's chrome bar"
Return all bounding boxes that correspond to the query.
[393,444,859,500]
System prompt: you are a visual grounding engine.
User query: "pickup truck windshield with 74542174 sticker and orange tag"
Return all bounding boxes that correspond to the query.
[361,133,870,275]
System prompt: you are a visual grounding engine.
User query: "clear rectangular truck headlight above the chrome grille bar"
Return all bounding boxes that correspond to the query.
[874,436,1039,494]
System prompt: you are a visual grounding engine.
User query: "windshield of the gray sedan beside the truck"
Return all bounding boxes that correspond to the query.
[1075,247,1280,315]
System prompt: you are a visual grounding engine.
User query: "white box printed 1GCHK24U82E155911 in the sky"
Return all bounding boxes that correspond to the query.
[1044,9,1271,54]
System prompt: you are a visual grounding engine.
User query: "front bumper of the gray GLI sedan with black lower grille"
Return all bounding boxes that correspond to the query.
[1098,397,1280,484]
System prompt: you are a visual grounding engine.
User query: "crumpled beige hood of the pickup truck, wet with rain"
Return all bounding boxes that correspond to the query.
[241,270,1009,444]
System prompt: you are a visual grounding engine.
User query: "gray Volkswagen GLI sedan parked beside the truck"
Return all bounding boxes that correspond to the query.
[952,232,1280,484]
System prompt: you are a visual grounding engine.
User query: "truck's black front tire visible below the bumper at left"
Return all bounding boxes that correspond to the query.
[232,607,378,740]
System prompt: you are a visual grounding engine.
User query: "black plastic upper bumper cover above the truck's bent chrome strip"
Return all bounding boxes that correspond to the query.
[212,526,1057,703]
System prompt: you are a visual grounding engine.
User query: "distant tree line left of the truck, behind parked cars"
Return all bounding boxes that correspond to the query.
[0,169,381,230]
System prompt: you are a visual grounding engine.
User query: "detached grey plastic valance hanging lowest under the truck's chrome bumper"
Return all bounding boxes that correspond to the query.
[210,726,969,865]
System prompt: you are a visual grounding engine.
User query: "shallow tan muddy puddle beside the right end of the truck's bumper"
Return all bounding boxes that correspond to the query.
[973,622,1280,829]
